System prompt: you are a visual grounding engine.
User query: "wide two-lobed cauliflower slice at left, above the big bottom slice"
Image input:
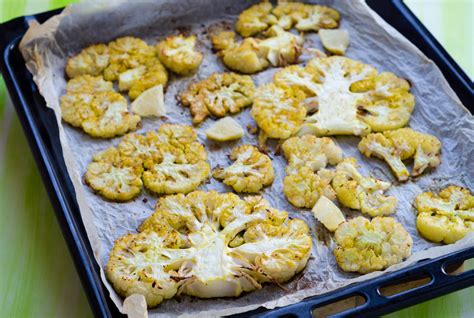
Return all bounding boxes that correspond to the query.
[85,124,210,201]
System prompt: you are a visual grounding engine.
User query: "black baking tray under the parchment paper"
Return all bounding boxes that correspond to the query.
[0,0,474,317]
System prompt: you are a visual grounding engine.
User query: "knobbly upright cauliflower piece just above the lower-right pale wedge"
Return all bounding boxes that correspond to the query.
[282,135,342,208]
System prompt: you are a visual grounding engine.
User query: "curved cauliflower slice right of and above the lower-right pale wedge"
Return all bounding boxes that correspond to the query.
[332,158,397,217]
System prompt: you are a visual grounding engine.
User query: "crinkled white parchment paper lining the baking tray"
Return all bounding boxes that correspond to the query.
[21,0,474,317]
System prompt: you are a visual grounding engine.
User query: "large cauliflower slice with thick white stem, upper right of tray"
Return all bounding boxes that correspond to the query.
[274,56,414,136]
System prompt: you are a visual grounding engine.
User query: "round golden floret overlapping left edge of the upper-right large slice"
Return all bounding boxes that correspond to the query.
[251,83,306,139]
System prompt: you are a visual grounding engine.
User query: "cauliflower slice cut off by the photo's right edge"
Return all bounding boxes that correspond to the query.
[415,186,474,244]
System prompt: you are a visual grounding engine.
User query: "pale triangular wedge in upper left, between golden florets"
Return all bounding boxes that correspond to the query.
[130,85,166,117]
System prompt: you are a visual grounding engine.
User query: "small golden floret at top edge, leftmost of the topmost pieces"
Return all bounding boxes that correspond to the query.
[235,1,278,37]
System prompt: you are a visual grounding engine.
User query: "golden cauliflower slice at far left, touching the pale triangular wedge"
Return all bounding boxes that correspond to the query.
[60,75,140,138]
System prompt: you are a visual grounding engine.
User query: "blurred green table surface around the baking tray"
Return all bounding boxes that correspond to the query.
[0,0,474,317]
